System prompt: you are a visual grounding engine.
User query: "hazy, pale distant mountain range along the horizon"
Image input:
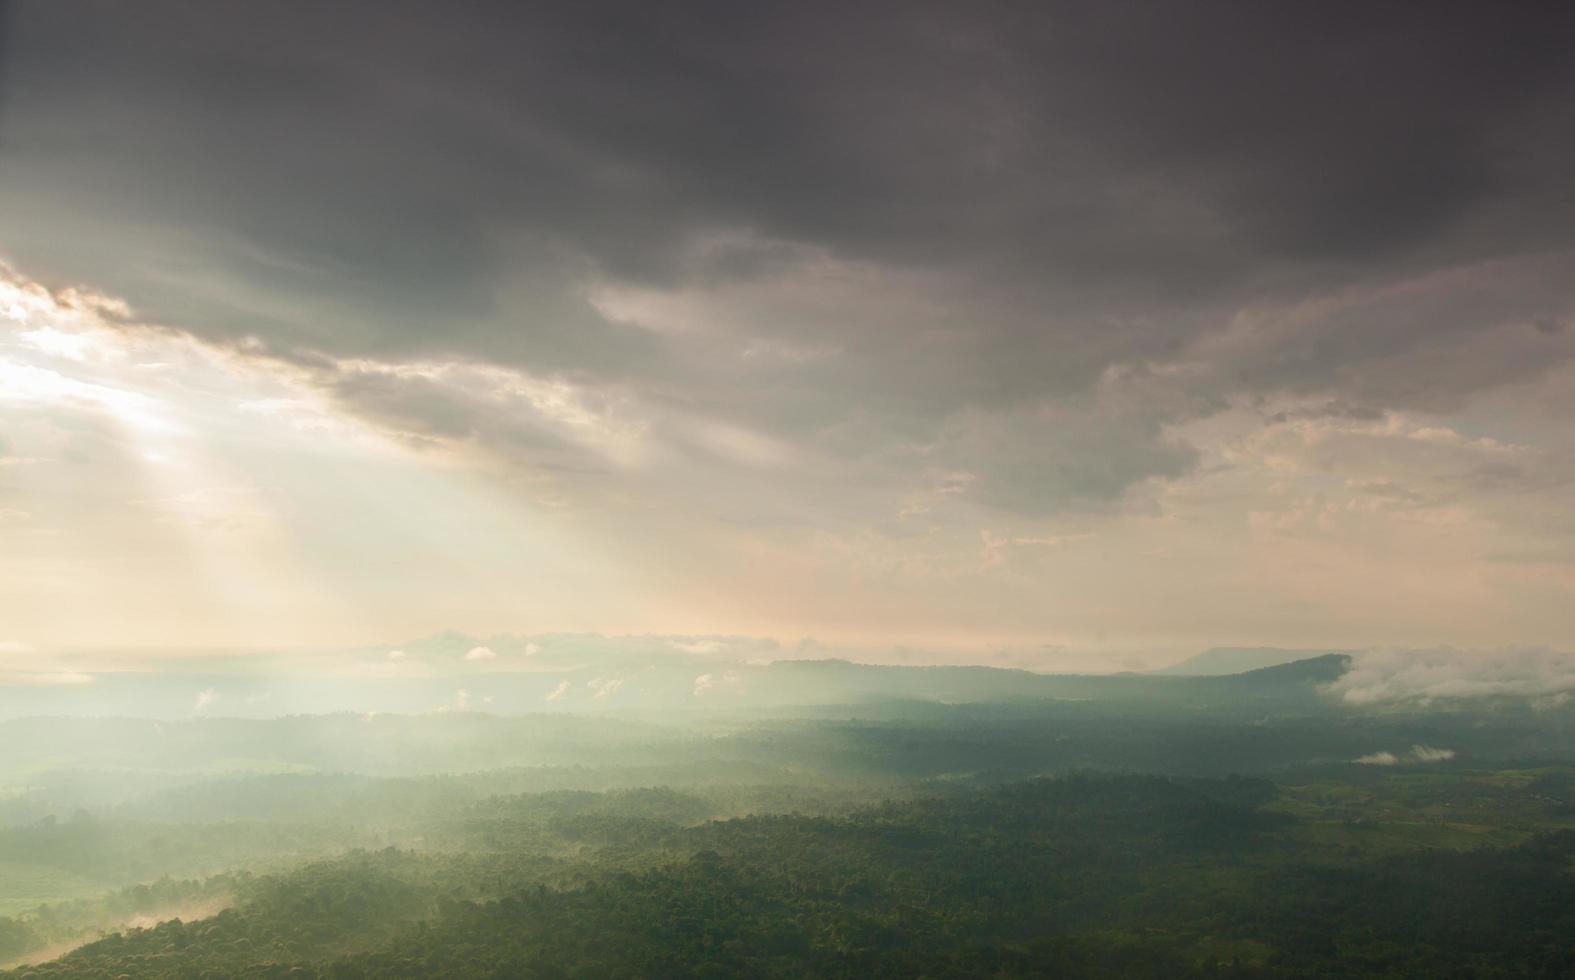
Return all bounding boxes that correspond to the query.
[0,633,1350,718]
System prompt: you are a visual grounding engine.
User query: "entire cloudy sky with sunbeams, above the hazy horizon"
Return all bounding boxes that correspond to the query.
[0,0,1575,665]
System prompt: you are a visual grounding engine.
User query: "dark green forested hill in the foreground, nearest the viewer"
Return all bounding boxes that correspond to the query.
[16,777,1575,980]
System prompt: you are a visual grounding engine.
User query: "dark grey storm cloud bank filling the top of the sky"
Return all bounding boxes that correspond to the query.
[0,0,1575,519]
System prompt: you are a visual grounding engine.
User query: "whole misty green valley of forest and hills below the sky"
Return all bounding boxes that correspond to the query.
[0,644,1575,977]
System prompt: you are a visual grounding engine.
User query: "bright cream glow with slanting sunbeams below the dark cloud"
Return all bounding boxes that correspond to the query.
[0,264,652,649]
